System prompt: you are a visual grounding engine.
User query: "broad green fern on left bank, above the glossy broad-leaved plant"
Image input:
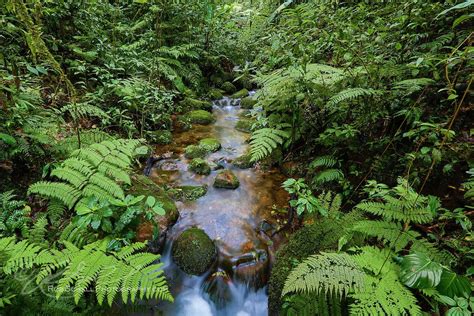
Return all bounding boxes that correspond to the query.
[28,140,140,209]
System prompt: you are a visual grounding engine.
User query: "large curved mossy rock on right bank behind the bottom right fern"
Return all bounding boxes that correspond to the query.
[268,212,362,315]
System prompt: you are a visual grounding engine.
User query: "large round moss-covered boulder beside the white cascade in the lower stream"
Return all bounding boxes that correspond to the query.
[172,228,217,275]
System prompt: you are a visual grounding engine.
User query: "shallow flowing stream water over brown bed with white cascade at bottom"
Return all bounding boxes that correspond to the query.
[151,98,288,316]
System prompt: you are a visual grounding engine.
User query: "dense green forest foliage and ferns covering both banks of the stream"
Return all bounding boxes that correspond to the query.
[0,0,474,315]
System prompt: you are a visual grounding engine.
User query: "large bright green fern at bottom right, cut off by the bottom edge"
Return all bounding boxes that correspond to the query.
[283,247,421,315]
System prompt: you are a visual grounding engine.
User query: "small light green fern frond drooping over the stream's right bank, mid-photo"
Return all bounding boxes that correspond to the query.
[250,128,289,161]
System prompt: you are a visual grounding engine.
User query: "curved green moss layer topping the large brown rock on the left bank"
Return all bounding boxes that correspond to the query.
[128,175,179,223]
